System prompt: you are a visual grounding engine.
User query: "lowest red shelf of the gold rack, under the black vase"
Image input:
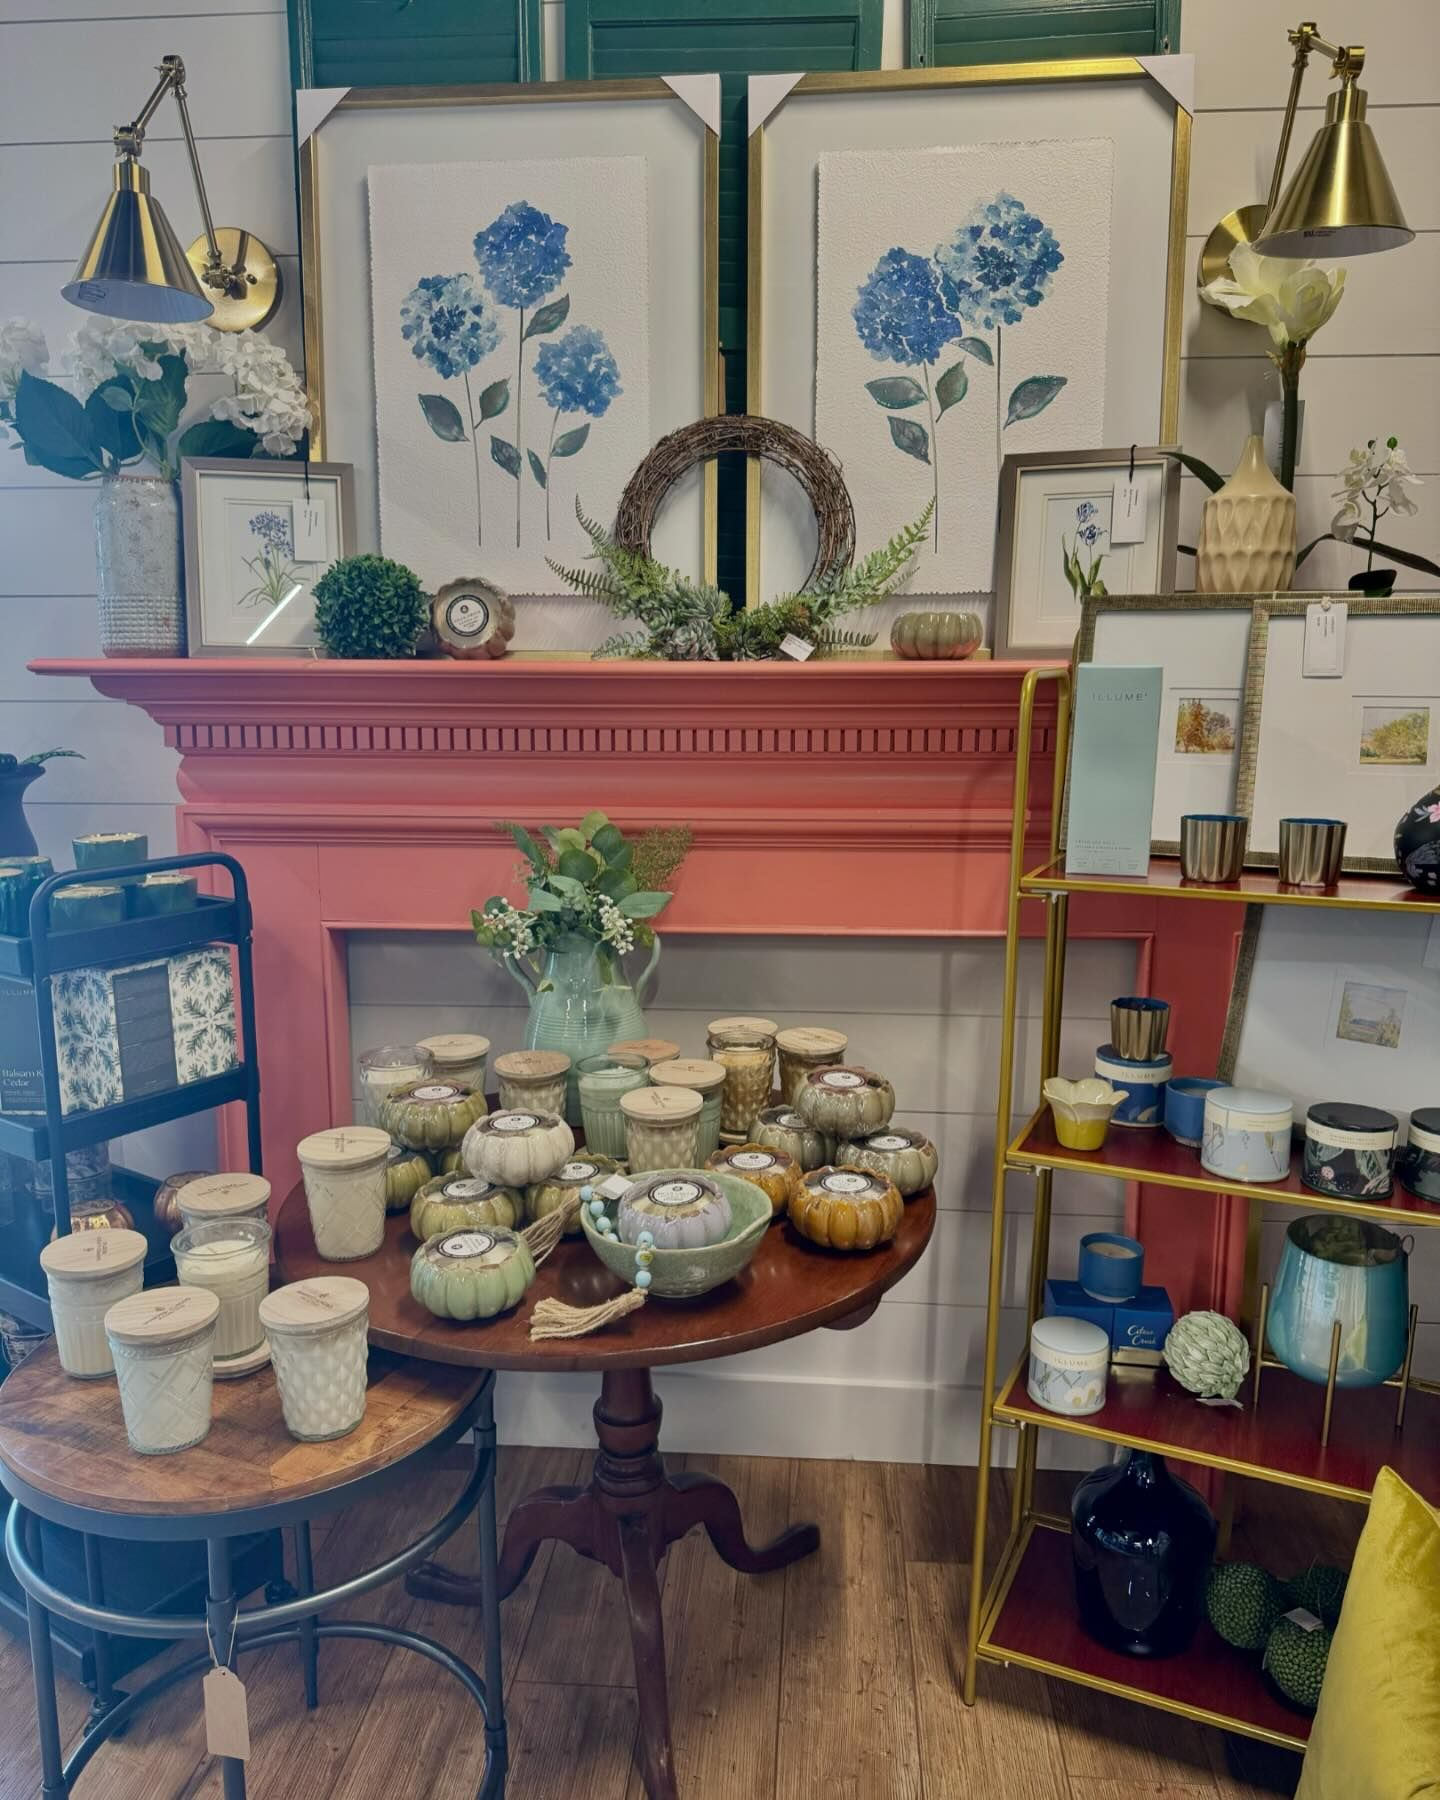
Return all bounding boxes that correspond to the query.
[981,1525,1310,1750]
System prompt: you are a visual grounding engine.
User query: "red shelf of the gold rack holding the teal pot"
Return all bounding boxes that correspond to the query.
[995,1361,1440,1505]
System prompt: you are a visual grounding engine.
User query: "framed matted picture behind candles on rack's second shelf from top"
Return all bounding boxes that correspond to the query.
[1220,905,1440,1116]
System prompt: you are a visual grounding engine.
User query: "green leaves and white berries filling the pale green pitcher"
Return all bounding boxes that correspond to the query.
[470,812,695,981]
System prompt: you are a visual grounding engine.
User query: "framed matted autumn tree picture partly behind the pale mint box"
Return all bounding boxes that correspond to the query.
[1076,594,1253,855]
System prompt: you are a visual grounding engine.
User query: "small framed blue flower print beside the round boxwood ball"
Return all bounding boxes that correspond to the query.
[182,457,355,657]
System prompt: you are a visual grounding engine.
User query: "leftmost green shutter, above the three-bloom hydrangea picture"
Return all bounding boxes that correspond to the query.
[288,0,542,88]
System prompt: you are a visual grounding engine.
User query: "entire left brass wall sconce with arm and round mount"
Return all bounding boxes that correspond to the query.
[59,56,281,331]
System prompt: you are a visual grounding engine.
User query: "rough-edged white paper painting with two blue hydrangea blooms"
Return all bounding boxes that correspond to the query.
[815,137,1114,594]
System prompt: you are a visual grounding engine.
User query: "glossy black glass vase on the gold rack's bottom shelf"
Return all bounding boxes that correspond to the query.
[1069,1451,1215,1656]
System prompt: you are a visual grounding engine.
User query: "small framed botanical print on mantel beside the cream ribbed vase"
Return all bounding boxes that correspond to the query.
[994,446,1181,661]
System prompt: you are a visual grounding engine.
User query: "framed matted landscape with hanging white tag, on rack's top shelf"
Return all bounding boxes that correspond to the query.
[1237,596,1440,873]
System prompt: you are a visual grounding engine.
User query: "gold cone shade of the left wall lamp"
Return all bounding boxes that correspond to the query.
[59,157,214,326]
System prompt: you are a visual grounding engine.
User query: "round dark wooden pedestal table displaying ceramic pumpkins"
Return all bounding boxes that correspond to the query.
[275,1188,934,1800]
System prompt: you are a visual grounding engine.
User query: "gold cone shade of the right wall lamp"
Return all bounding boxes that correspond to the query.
[1255,83,1415,257]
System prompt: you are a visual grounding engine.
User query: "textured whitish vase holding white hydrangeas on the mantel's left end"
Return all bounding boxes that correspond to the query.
[95,475,185,657]
